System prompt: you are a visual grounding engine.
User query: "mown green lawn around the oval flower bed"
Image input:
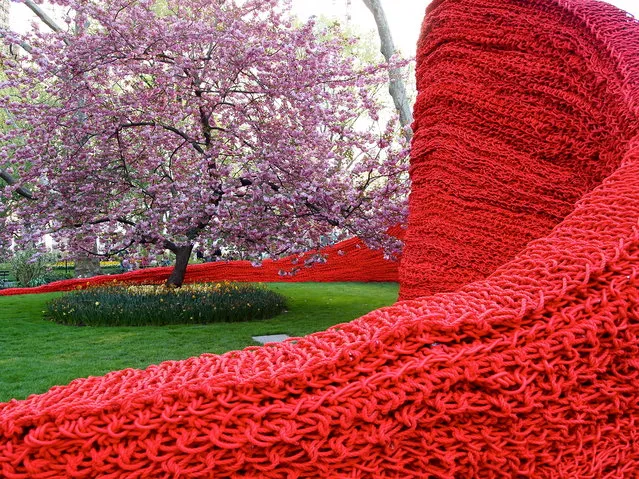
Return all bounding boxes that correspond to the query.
[0,283,397,402]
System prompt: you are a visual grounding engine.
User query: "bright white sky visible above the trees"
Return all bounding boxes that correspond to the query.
[10,0,639,57]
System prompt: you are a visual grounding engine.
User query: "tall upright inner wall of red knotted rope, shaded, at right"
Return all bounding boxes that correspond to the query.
[400,0,634,299]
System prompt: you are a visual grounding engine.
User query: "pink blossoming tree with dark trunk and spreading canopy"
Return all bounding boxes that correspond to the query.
[0,0,408,286]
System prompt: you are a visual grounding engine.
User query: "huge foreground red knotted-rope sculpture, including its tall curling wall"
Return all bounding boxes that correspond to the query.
[0,0,639,479]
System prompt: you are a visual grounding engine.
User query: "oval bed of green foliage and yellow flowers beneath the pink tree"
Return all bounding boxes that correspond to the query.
[46,282,286,326]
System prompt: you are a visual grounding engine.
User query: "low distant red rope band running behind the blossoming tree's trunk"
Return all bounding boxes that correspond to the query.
[0,235,403,296]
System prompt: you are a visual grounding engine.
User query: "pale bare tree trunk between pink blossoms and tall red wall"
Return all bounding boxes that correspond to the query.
[363,0,413,140]
